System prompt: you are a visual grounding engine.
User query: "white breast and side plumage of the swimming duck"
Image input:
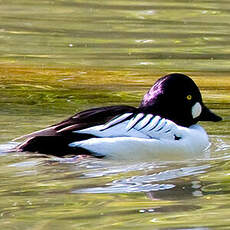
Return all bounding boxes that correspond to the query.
[70,113,209,160]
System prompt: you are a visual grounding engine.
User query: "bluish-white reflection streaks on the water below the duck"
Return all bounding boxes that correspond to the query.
[72,165,210,193]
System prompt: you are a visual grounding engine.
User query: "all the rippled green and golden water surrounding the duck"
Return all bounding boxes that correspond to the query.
[0,0,230,230]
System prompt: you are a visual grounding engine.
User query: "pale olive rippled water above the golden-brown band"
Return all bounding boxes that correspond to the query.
[0,0,230,73]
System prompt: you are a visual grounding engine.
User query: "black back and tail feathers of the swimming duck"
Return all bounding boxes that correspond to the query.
[17,105,137,156]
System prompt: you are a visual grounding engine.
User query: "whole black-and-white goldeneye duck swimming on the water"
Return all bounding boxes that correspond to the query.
[17,73,221,159]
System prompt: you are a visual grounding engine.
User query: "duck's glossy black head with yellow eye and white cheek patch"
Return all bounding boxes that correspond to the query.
[139,73,222,127]
